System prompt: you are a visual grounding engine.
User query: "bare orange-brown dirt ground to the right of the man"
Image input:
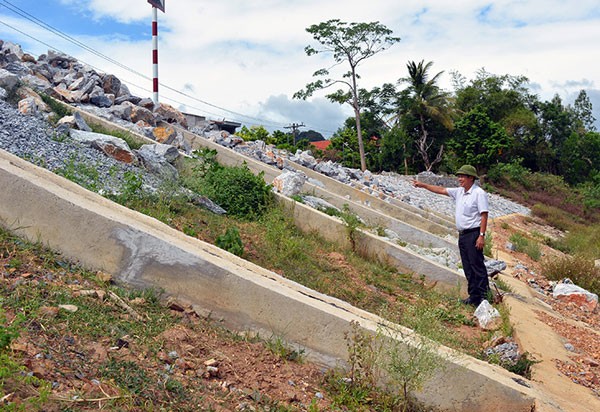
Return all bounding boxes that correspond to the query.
[492,215,600,411]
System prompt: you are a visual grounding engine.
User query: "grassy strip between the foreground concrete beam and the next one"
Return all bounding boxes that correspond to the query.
[103,172,488,355]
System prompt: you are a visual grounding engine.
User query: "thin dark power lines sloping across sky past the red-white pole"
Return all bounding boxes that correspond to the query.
[0,0,332,133]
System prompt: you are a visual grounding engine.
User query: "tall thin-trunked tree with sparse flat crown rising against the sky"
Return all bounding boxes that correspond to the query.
[294,19,400,171]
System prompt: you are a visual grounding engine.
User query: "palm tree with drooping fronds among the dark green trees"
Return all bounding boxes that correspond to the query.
[399,60,453,171]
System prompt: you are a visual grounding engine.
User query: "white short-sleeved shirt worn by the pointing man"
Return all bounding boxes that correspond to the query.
[446,184,489,230]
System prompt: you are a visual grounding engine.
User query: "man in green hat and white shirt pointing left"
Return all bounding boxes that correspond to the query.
[413,165,490,306]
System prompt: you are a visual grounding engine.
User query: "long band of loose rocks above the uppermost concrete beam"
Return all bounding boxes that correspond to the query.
[0,40,529,218]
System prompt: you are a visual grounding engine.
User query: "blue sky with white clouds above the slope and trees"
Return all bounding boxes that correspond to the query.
[0,0,600,136]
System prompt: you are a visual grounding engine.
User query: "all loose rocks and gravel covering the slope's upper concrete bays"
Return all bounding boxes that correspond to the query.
[0,40,529,270]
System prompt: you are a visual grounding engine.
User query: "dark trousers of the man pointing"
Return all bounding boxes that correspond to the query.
[458,231,490,302]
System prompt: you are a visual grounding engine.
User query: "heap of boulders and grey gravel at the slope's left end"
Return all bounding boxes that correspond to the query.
[0,40,225,214]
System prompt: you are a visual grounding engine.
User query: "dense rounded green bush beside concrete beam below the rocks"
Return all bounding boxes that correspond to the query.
[200,164,273,220]
